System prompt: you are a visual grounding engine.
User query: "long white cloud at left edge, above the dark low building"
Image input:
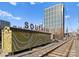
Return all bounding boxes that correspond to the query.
[0,10,21,20]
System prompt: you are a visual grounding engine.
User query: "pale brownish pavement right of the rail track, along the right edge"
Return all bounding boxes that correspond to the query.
[69,37,79,57]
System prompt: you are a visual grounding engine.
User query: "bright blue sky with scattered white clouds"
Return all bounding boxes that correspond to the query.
[0,2,79,32]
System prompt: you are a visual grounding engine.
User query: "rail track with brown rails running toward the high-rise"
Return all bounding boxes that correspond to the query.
[42,40,74,57]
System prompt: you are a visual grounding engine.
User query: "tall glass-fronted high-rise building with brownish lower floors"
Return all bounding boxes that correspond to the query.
[44,4,64,38]
